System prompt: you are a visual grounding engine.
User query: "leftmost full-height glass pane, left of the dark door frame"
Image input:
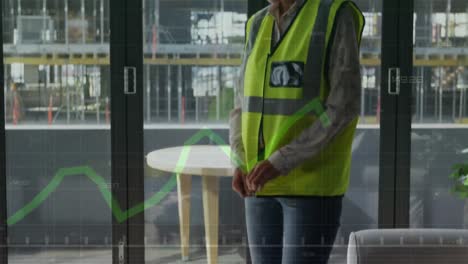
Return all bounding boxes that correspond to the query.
[2,0,112,264]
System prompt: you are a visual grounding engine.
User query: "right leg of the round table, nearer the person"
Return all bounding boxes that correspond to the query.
[202,176,219,264]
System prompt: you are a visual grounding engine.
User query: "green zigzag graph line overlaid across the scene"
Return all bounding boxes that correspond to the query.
[7,99,330,226]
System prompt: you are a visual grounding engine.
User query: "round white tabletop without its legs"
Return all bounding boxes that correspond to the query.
[146,145,234,177]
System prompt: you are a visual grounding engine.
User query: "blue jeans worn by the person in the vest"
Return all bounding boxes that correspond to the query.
[245,196,343,264]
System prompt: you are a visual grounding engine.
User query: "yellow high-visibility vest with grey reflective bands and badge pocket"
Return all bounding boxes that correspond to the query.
[242,0,365,196]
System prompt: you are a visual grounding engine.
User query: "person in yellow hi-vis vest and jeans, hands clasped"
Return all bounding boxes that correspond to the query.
[229,0,365,264]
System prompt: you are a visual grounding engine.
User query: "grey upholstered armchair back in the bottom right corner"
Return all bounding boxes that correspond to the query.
[348,229,468,264]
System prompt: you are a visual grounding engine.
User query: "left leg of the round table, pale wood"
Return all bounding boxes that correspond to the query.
[177,174,192,261]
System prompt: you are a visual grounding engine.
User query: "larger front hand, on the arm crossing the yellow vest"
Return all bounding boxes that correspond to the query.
[247,160,281,192]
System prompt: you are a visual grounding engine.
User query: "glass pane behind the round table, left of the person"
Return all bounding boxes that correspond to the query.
[142,0,247,263]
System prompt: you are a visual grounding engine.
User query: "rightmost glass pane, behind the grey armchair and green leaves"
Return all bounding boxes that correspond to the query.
[410,0,468,228]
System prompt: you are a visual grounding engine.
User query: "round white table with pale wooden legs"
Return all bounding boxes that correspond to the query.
[146,145,234,264]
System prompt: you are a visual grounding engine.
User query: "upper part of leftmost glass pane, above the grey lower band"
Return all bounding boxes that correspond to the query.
[2,0,110,126]
